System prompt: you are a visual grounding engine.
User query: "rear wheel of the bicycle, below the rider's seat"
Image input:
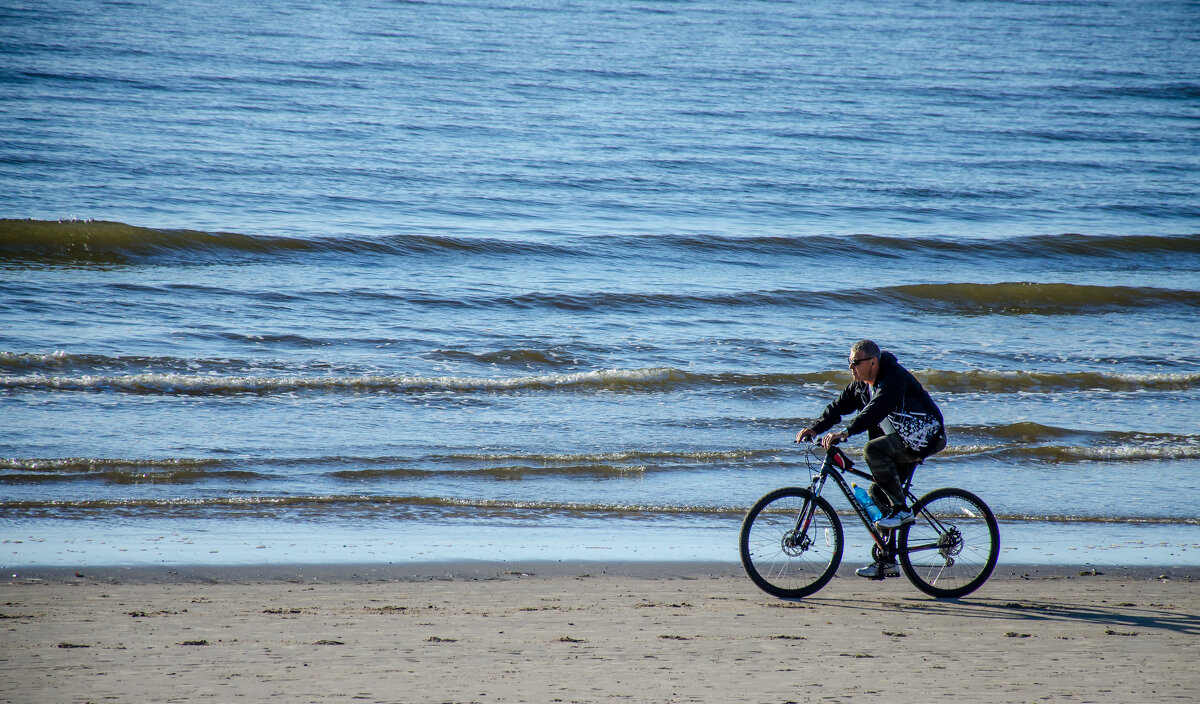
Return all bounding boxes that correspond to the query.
[896,488,1000,598]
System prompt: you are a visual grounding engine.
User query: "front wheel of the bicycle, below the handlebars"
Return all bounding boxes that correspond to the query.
[740,487,842,598]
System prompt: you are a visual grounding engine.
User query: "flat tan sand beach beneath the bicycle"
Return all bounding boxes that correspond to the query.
[0,564,1200,703]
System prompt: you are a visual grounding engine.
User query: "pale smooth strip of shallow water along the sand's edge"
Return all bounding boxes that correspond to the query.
[9,518,1200,574]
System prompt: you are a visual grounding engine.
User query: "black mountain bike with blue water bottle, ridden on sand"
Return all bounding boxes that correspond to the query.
[739,445,1000,598]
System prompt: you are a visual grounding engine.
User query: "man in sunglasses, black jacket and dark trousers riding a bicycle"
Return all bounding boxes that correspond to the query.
[796,339,946,579]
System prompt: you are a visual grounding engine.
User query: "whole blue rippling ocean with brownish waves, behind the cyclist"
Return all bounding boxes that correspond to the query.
[0,0,1200,570]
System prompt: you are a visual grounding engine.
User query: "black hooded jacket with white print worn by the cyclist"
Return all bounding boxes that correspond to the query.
[812,351,946,458]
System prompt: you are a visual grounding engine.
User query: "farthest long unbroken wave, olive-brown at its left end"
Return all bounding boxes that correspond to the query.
[0,219,1200,264]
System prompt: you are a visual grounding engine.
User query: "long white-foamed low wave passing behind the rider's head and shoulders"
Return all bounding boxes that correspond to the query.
[0,367,1200,396]
